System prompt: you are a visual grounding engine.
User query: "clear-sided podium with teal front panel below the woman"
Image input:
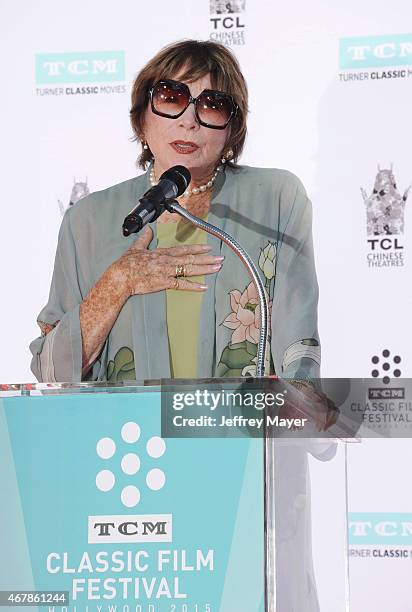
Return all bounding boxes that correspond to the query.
[0,380,348,612]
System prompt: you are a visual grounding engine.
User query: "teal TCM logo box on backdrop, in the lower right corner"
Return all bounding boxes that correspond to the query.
[348,512,412,545]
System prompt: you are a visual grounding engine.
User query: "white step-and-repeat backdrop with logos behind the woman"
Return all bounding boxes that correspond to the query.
[0,0,412,612]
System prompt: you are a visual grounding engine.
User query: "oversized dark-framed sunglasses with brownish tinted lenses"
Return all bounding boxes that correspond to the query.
[149,79,238,130]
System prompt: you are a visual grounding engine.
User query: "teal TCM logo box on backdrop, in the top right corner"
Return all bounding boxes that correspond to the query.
[339,34,412,70]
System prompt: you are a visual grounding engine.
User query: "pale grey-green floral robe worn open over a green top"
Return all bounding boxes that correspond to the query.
[30,166,320,382]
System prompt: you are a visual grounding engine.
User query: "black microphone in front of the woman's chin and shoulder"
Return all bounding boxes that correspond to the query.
[122,166,191,236]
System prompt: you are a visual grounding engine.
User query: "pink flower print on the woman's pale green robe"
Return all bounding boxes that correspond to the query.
[223,283,272,344]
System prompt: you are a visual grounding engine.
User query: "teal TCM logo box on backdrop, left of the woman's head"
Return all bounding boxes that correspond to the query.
[36,51,125,85]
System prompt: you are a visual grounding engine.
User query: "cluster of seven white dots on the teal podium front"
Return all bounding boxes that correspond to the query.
[96,421,166,508]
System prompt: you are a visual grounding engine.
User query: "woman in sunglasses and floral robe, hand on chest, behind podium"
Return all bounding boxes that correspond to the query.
[30,41,320,382]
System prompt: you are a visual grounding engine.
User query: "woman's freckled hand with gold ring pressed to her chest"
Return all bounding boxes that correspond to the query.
[111,226,224,299]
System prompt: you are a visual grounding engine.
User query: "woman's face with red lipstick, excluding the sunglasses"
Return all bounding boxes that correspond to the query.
[144,75,230,182]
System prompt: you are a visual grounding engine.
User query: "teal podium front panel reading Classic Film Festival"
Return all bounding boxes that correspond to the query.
[0,389,265,612]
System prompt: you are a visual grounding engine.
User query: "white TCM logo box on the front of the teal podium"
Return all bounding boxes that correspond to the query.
[88,514,172,544]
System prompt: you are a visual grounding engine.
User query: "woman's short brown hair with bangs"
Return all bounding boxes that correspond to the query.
[130,40,248,169]
